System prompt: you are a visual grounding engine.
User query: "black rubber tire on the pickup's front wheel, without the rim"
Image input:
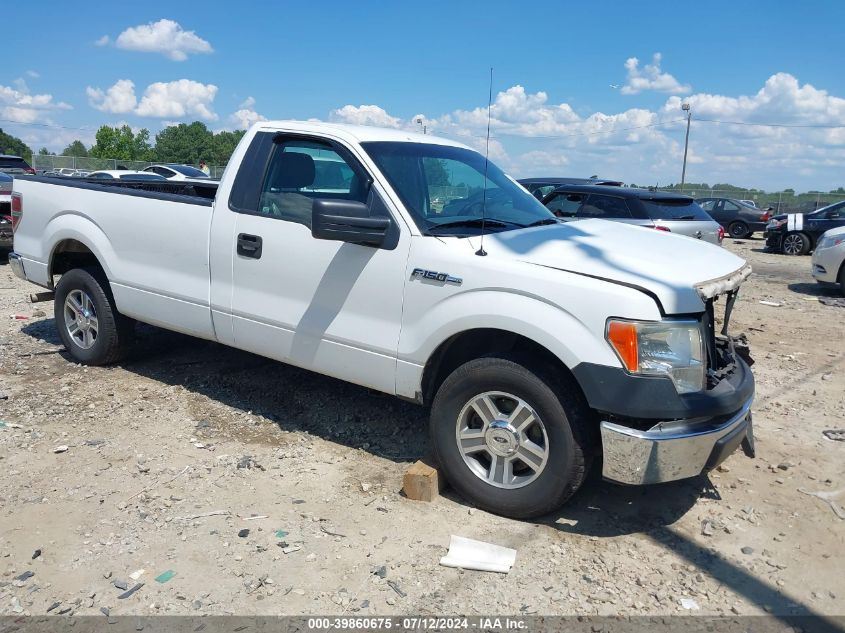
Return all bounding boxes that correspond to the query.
[431,357,595,519]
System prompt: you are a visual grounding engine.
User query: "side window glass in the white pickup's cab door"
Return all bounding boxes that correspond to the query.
[250,138,368,228]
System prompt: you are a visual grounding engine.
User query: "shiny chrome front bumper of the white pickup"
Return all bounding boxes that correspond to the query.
[601,398,754,485]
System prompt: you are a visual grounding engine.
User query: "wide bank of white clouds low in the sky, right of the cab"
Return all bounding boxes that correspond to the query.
[329,72,845,191]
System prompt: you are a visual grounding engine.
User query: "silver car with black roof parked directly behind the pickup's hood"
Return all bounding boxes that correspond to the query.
[543,185,725,244]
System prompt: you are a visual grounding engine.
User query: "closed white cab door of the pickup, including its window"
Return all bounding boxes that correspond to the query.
[224,133,410,393]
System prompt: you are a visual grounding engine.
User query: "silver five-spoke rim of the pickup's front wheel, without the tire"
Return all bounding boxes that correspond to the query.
[455,391,549,489]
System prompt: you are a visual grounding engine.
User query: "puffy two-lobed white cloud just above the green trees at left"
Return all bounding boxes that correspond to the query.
[85,79,217,121]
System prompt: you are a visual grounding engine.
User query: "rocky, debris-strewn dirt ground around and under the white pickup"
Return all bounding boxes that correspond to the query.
[0,239,845,615]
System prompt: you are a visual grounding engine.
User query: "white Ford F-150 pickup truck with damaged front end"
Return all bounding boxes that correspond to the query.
[10,122,754,517]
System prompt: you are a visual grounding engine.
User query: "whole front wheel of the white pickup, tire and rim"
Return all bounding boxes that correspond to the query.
[431,358,591,519]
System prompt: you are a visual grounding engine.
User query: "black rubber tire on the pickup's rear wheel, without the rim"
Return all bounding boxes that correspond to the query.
[53,268,135,365]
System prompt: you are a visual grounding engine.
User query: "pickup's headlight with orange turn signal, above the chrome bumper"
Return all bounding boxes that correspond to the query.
[605,319,706,393]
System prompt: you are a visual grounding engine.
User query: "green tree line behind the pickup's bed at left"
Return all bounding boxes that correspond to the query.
[0,121,245,165]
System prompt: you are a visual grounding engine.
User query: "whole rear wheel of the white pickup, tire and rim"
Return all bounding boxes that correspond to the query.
[53,268,135,365]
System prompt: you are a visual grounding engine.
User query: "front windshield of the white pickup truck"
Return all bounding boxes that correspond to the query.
[362,142,556,236]
